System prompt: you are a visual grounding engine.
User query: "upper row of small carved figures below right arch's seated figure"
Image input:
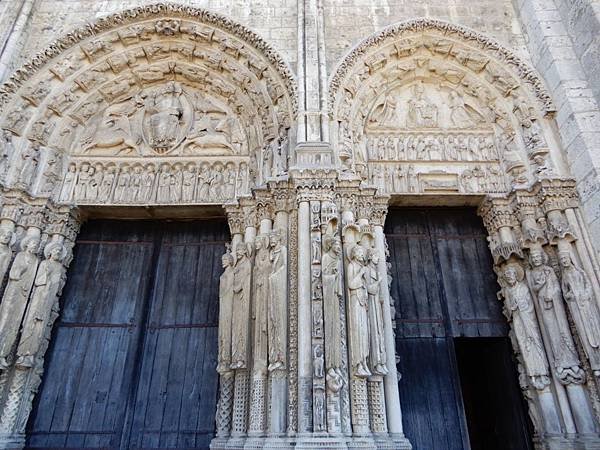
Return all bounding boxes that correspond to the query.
[367,133,498,161]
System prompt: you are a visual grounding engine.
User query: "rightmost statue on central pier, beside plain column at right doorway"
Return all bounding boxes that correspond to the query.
[365,249,388,375]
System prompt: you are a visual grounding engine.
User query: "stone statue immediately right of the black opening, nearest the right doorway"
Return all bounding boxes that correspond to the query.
[500,264,550,389]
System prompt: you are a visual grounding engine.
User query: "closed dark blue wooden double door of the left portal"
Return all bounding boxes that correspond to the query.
[27,221,227,449]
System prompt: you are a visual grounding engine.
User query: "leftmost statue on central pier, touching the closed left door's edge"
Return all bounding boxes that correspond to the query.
[217,249,234,373]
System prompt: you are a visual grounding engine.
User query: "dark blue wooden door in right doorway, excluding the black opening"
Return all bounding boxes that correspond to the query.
[386,208,526,450]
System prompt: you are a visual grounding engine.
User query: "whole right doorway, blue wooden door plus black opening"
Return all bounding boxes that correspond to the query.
[385,208,532,450]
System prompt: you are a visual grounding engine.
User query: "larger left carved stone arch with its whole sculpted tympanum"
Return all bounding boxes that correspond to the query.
[0,4,296,204]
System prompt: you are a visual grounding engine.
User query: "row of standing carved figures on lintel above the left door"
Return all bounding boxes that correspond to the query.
[59,161,251,204]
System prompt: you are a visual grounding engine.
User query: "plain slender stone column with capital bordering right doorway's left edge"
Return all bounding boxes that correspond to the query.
[371,198,412,449]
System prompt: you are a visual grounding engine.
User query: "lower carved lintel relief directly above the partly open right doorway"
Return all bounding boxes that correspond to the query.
[371,163,506,194]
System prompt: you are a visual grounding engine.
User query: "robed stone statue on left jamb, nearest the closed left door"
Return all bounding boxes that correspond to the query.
[16,242,65,367]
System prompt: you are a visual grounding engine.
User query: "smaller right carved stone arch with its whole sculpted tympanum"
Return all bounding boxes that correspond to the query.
[329,19,566,195]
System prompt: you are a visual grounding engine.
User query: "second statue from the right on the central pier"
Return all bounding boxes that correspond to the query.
[348,244,371,378]
